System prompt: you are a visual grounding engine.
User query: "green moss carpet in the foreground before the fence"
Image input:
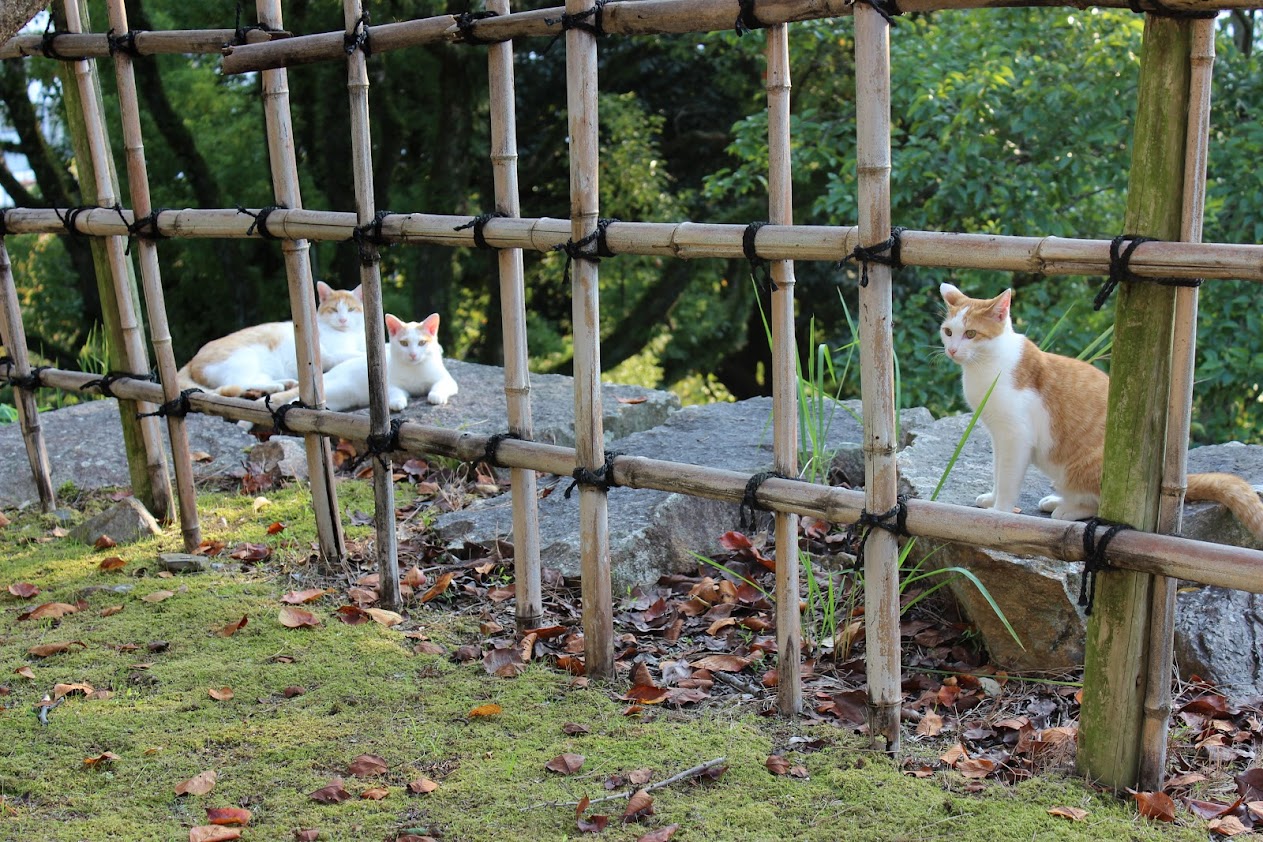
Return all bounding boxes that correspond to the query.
[0,481,1206,842]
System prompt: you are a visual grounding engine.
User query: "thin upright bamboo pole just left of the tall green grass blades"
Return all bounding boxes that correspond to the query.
[767,24,802,716]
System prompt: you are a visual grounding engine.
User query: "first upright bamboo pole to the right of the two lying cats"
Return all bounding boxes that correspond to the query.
[486,0,544,634]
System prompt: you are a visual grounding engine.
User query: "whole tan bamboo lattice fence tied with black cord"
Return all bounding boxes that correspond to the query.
[0,0,1263,786]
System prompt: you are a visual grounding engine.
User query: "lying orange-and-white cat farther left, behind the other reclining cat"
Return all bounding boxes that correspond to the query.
[178,282,365,398]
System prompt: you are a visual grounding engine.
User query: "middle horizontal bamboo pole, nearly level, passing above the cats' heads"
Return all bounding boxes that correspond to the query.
[5,208,1263,280]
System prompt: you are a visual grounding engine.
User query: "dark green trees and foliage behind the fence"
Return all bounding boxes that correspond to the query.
[0,0,1263,442]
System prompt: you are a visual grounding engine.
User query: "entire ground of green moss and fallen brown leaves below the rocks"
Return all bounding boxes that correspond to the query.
[0,461,1263,841]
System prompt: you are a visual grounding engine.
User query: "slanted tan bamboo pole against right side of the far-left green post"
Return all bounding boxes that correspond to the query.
[62,0,174,523]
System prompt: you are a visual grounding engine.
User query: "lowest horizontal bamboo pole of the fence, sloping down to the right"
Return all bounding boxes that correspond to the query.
[14,364,1263,593]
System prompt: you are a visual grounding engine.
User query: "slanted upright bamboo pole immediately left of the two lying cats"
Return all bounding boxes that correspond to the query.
[109,0,202,552]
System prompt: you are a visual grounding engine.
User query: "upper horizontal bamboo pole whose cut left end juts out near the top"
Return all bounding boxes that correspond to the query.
[214,0,1242,74]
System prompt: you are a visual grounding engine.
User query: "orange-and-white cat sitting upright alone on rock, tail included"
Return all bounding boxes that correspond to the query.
[938,284,1263,539]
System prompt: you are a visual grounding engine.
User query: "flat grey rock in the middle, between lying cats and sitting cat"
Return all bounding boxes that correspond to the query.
[436,398,930,591]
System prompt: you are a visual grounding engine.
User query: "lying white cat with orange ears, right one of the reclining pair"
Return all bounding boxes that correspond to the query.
[270,313,457,413]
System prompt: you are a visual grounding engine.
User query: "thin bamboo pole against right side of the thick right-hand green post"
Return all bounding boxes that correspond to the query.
[1138,19,1215,790]
